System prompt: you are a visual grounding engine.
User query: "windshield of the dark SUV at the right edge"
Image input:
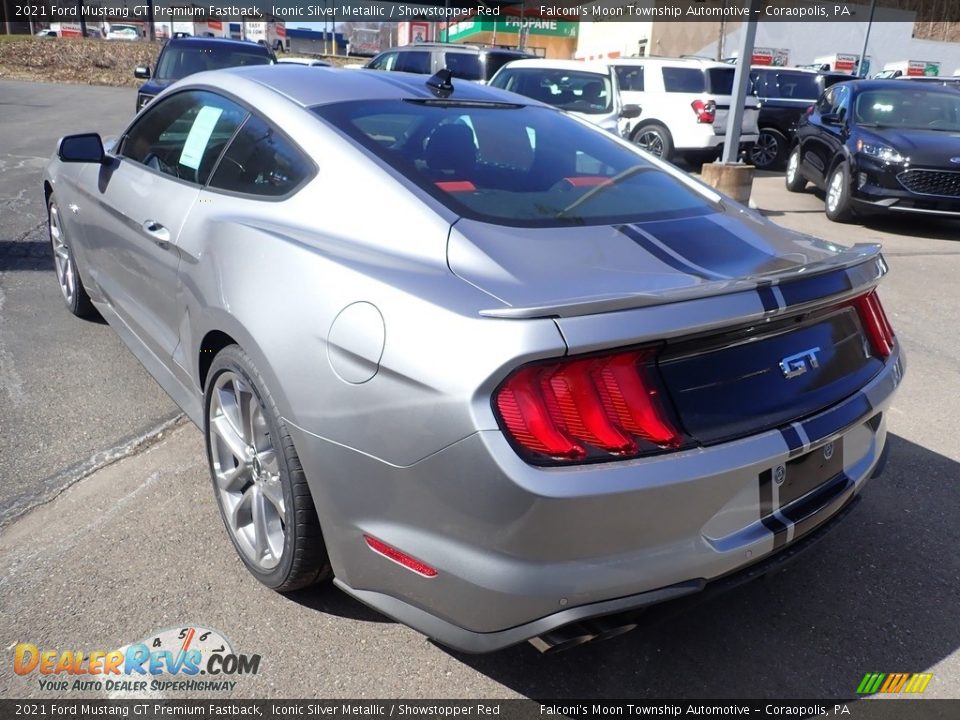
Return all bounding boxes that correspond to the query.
[854,87,960,132]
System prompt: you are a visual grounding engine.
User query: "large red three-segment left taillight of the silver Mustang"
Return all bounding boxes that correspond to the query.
[494,348,684,464]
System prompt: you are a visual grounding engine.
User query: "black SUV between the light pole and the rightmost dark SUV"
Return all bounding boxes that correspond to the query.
[750,67,852,170]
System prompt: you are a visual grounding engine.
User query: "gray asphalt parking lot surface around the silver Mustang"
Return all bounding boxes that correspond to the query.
[0,77,960,698]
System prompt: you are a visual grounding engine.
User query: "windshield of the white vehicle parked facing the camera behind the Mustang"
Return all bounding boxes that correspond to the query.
[490,66,613,115]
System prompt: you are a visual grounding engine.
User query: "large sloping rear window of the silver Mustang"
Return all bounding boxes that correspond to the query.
[313,100,715,227]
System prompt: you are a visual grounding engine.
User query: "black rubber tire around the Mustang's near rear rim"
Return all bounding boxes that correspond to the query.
[204,345,332,592]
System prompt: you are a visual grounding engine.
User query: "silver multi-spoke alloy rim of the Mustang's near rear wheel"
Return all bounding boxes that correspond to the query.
[207,370,287,571]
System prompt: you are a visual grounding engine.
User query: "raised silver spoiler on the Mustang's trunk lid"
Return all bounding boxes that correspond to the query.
[480,243,887,320]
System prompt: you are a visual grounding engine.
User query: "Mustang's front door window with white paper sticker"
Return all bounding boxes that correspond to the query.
[120,90,247,185]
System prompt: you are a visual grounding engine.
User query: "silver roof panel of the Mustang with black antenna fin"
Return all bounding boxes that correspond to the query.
[199,64,543,107]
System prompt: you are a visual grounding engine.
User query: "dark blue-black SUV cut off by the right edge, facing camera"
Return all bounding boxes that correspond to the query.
[786,80,960,222]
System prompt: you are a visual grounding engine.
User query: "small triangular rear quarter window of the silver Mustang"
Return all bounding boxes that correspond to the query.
[210,115,313,197]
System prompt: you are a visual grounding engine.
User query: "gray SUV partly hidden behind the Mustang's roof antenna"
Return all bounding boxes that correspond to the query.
[364,43,536,83]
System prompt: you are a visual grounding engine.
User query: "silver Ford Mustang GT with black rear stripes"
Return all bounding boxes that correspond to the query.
[43,66,903,652]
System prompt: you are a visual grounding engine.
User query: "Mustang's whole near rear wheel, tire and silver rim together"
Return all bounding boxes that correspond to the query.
[204,345,331,592]
